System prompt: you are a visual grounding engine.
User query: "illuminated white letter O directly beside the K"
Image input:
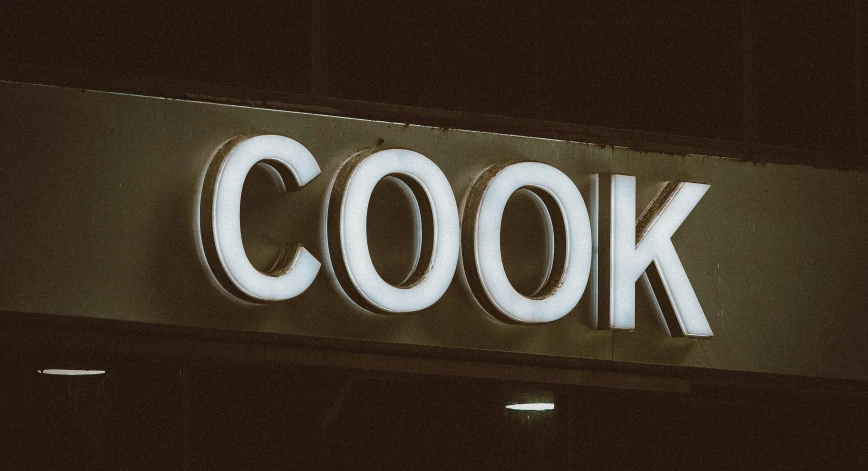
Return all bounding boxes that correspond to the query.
[461,161,593,323]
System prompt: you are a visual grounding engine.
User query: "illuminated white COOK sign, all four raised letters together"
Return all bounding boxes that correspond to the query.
[197,135,713,338]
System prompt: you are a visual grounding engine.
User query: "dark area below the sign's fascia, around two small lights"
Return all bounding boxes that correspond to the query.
[0,348,868,470]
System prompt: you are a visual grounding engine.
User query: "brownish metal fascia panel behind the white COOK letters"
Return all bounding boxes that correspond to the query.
[0,83,868,380]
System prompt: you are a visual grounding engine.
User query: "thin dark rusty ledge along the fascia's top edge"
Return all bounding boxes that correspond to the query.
[0,61,868,172]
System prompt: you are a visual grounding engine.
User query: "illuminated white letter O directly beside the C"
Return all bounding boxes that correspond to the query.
[326,149,460,313]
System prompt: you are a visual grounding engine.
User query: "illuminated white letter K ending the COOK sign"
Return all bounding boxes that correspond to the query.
[597,174,713,338]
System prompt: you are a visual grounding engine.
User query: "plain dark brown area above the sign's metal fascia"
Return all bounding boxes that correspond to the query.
[0,0,868,159]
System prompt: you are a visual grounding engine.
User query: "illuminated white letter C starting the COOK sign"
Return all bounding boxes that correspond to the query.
[198,135,320,302]
